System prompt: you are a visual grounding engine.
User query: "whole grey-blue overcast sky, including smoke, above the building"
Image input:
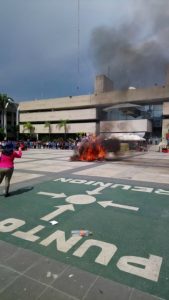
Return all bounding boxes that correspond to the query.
[0,0,169,102]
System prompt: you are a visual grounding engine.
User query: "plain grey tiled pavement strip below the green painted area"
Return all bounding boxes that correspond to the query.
[0,241,160,300]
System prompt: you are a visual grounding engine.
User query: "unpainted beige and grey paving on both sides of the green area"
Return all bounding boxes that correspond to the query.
[0,149,169,300]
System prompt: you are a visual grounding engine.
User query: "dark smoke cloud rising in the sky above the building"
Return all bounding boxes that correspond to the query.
[91,0,169,88]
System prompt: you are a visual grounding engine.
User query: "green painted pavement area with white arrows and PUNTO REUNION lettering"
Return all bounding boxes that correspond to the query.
[0,181,169,299]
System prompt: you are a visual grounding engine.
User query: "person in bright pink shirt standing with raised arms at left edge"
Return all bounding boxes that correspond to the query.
[0,142,22,197]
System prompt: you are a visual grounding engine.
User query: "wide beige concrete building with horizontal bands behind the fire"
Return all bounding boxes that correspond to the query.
[19,72,169,144]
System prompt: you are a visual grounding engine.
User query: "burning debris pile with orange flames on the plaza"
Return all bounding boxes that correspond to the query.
[71,135,120,161]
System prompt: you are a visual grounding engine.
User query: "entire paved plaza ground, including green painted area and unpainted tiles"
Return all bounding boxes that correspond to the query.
[0,149,169,300]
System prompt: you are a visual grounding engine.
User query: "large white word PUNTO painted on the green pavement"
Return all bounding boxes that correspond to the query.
[0,216,163,282]
